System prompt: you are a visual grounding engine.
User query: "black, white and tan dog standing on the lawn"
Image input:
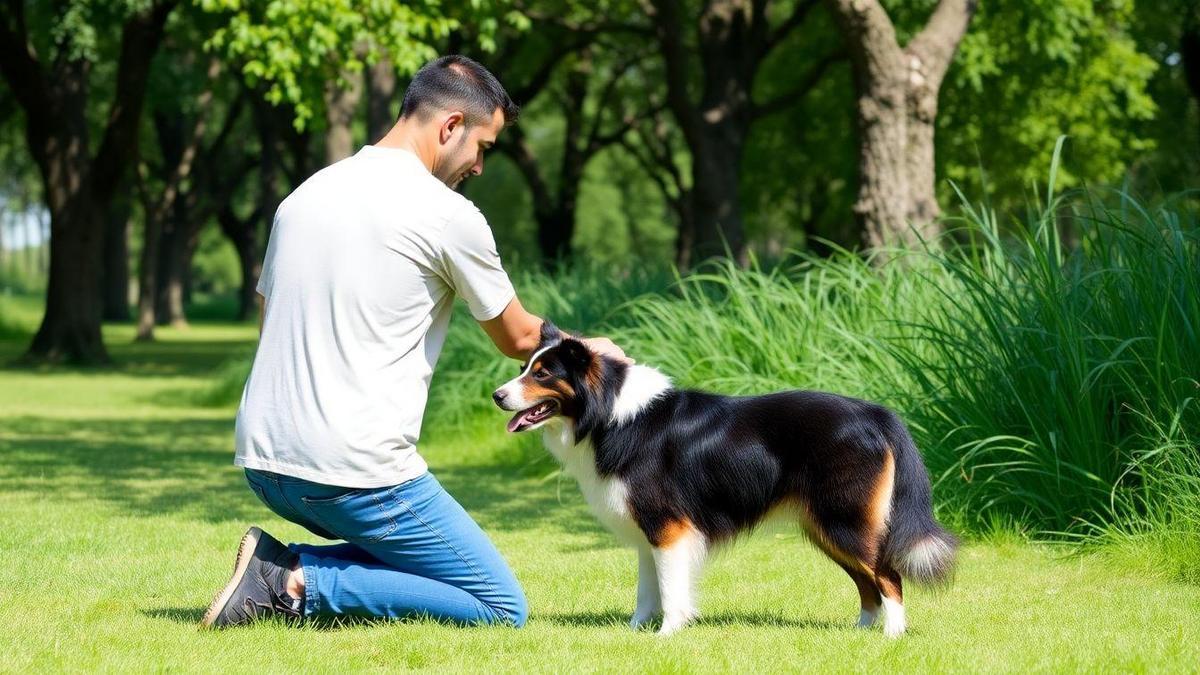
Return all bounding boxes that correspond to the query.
[492,322,958,638]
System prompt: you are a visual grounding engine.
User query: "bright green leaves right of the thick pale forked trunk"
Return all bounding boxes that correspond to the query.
[937,0,1170,198]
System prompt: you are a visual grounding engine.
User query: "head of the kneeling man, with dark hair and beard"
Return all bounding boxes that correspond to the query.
[400,55,518,187]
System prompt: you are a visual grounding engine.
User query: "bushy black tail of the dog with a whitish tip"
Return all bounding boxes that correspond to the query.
[883,419,959,586]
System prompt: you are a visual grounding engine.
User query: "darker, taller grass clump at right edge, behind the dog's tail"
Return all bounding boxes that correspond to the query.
[889,178,1200,547]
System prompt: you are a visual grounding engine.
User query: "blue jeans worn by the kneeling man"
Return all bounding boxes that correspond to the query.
[246,468,529,627]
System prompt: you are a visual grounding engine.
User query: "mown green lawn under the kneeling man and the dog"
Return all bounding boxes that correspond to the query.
[0,324,1200,671]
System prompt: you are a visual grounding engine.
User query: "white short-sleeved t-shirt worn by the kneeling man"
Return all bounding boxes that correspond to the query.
[234,145,514,488]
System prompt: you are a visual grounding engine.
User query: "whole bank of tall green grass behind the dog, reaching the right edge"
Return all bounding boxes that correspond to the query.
[625,168,1200,562]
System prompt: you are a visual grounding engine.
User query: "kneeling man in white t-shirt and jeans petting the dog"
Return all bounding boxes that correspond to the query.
[202,56,624,627]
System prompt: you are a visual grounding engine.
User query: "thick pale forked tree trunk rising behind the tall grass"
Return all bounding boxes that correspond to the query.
[827,0,976,251]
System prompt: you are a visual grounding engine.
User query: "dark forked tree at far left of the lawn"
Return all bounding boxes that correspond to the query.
[0,0,175,363]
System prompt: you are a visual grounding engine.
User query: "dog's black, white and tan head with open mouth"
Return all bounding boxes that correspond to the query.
[492,321,625,438]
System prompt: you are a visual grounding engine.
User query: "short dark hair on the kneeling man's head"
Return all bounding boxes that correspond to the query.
[400,54,521,126]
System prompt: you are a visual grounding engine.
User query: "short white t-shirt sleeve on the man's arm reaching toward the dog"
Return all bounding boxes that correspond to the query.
[442,204,516,321]
